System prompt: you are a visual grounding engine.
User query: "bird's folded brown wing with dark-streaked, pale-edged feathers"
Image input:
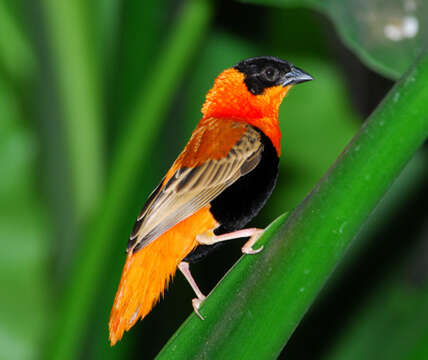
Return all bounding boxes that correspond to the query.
[128,121,263,252]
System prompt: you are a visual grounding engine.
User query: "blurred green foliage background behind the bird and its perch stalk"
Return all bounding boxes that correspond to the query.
[0,0,428,359]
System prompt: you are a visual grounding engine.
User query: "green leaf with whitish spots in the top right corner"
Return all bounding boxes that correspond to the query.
[242,0,428,79]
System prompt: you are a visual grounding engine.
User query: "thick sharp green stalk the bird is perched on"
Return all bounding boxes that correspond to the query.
[158,54,428,359]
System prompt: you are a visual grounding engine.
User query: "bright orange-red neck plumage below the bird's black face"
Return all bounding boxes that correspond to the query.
[202,68,290,156]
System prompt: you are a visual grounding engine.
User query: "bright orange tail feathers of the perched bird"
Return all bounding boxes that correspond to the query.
[109,208,217,346]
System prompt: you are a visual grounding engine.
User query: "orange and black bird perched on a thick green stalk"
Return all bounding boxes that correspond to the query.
[109,56,313,346]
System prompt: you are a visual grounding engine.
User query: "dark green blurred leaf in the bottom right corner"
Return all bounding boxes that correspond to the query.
[324,238,428,360]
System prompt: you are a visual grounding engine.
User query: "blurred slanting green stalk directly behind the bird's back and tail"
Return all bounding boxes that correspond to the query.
[48,0,212,360]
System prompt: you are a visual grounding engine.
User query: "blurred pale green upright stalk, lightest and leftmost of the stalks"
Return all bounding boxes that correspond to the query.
[41,0,104,221]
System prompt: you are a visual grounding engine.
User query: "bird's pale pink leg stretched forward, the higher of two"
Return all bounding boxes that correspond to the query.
[196,228,263,254]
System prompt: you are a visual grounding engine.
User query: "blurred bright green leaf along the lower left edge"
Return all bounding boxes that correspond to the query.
[0,78,51,360]
